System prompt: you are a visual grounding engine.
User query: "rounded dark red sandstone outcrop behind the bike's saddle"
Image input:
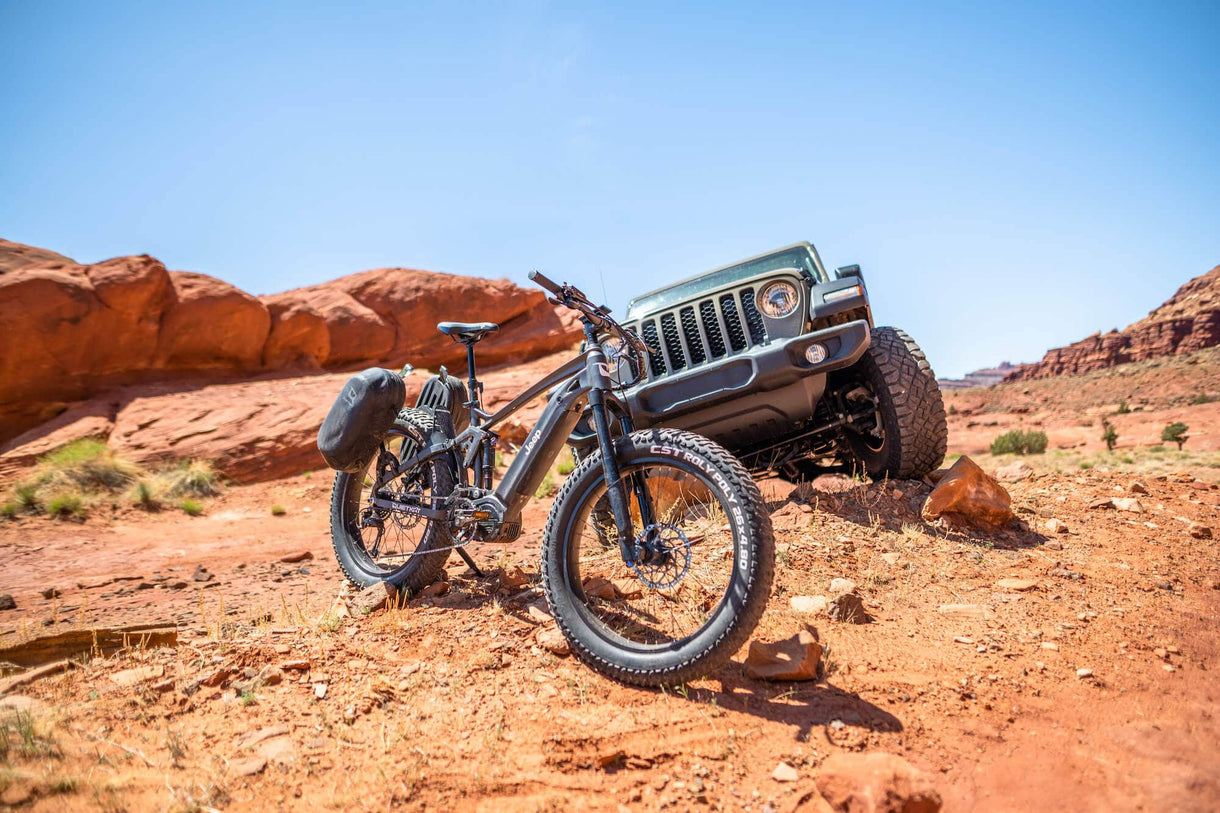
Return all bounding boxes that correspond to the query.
[0,240,580,443]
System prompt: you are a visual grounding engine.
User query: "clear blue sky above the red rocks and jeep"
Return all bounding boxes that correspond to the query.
[0,0,1220,375]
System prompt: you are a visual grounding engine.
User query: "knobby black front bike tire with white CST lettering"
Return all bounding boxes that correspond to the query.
[542,428,775,686]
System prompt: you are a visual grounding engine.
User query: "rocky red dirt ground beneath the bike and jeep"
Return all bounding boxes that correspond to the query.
[0,351,1220,812]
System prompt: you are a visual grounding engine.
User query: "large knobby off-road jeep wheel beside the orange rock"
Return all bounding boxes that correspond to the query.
[843,327,949,480]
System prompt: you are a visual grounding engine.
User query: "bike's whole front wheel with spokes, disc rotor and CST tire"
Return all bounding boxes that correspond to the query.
[542,430,775,686]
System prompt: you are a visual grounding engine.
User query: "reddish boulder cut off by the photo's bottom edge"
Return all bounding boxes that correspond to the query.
[815,752,942,813]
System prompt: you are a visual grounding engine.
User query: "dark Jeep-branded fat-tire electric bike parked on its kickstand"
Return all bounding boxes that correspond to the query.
[331,271,775,686]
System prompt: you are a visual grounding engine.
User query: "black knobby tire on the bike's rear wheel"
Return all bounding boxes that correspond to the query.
[331,409,454,593]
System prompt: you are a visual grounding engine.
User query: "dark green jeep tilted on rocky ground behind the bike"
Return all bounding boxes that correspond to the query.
[571,243,948,479]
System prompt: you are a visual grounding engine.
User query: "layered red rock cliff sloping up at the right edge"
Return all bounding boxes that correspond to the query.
[1004,265,1220,381]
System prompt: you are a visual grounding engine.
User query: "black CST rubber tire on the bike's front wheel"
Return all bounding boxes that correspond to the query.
[542,428,775,686]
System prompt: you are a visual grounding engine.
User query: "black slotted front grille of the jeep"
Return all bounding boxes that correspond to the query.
[639,288,766,378]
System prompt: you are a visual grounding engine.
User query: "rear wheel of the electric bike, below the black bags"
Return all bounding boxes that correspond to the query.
[331,409,454,593]
